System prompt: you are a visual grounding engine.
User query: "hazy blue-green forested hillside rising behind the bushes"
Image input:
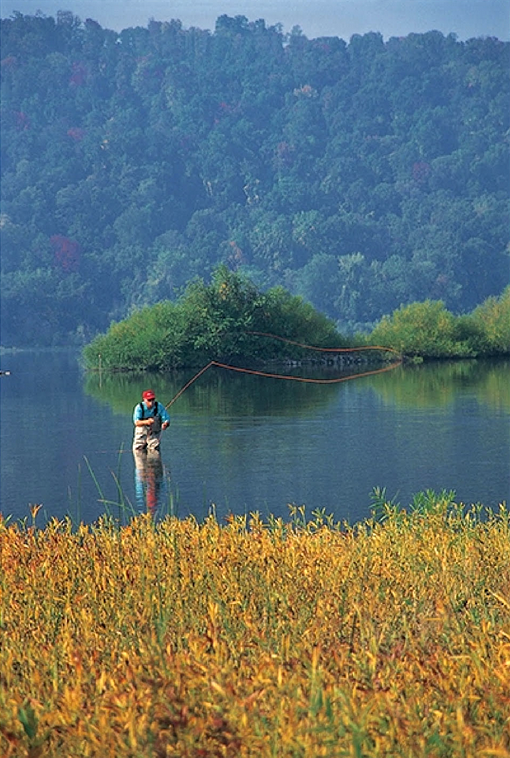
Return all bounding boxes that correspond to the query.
[1,12,510,345]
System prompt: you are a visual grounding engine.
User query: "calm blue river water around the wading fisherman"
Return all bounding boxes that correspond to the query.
[0,350,510,524]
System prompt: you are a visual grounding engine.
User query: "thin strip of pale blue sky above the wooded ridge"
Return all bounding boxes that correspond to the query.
[0,0,510,42]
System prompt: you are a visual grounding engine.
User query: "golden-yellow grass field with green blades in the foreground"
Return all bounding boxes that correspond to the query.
[0,501,510,758]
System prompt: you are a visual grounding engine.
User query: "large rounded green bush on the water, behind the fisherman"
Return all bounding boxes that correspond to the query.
[83,266,341,370]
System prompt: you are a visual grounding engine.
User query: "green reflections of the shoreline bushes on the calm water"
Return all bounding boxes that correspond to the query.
[85,359,510,418]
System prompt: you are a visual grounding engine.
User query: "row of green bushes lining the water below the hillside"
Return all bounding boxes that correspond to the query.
[83,266,510,371]
